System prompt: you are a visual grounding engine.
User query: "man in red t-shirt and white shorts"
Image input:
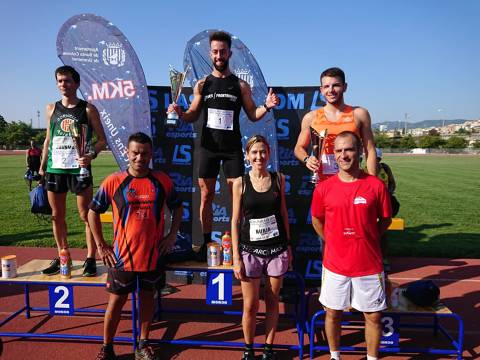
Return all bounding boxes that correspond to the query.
[311,131,391,360]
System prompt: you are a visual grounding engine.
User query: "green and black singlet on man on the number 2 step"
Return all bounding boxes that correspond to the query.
[47,100,92,175]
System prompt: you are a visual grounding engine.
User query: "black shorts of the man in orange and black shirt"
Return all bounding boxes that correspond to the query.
[107,268,165,295]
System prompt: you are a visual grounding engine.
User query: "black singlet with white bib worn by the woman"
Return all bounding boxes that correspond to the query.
[240,173,287,257]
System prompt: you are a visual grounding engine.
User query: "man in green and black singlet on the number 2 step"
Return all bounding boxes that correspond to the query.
[39,66,105,276]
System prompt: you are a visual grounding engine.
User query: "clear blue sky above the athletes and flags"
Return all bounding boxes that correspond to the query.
[0,0,480,127]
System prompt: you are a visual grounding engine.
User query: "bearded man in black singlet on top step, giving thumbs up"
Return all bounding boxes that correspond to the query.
[168,31,280,255]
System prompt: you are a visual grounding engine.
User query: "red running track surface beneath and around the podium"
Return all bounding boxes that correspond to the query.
[0,247,480,360]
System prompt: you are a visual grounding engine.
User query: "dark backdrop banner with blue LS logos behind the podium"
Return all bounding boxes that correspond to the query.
[149,86,322,286]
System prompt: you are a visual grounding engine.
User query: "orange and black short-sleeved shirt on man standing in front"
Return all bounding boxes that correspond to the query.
[90,171,182,271]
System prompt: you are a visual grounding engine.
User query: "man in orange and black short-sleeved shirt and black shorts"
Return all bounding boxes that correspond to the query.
[88,133,182,360]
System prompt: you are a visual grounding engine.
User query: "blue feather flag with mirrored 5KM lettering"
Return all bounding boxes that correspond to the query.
[57,14,151,170]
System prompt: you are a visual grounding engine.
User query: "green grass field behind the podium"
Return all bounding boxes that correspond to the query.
[0,154,480,258]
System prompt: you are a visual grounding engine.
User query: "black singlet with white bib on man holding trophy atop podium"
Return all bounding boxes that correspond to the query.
[201,74,242,152]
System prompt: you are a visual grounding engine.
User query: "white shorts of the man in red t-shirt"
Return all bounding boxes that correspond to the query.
[319,267,387,312]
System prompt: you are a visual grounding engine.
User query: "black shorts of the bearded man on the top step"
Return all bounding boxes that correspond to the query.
[198,148,245,179]
